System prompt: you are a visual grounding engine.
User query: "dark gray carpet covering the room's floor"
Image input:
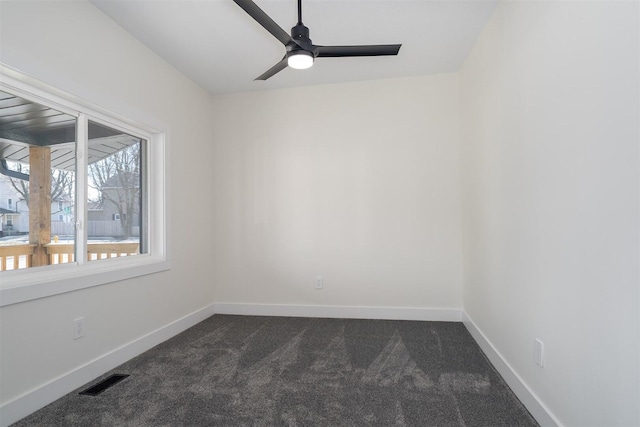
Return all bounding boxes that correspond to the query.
[15,315,537,427]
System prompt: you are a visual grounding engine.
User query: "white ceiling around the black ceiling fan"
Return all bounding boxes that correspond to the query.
[91,0,497,94]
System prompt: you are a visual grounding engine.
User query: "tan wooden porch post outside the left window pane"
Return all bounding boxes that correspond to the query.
[29,146,51,267]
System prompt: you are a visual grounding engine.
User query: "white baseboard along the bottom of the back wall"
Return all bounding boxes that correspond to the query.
[214,303,462,322]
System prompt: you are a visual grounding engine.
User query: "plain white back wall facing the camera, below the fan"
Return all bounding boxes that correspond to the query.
[211,74,462,309]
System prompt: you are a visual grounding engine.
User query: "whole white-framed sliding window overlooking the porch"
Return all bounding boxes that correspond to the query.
[0,65,169,305]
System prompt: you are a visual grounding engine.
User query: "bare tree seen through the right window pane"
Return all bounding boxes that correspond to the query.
[89,143,140,238]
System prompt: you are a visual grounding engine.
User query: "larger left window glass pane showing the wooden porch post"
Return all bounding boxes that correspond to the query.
[0,91,77,270]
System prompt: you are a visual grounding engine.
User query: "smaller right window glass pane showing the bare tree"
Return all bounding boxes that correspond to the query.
[87,121,147,261]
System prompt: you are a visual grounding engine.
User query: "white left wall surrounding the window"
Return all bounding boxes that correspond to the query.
[0,1,213,414]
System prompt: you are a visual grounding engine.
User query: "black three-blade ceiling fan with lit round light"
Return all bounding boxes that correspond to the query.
[233,0,402,80]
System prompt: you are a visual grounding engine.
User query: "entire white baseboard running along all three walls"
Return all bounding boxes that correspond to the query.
[0,303,562,427]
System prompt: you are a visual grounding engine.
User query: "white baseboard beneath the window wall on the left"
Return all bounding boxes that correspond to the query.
[0,305,214,427]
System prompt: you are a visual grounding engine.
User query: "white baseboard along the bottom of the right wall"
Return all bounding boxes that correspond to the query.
[462,312,562,427]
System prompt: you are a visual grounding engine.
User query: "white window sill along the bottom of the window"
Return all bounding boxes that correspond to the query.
[0,255,171,307]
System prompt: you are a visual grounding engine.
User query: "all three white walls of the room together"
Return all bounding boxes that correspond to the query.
[0,1,640,426]
